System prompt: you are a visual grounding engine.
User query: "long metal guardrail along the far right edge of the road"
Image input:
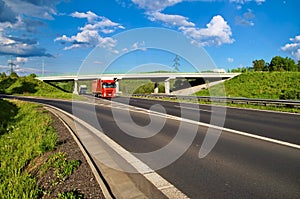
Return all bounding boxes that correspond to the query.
[132,94,300,108]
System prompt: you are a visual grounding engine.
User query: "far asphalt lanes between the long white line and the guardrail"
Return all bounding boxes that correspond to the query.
[114,97,300,145]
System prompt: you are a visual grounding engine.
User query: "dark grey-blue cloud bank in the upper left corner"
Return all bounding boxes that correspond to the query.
[0,0,60,57]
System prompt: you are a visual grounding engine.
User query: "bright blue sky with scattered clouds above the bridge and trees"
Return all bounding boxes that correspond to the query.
[0,0,300,75]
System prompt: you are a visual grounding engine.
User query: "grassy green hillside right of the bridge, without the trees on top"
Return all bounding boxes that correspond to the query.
[196,72,300,99]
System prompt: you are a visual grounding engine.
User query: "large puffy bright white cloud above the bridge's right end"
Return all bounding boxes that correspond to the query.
[180,15,234,46]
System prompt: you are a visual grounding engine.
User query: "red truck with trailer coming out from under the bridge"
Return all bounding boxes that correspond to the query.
[92,78,116,98]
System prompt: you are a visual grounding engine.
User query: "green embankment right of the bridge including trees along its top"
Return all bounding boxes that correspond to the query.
[196,56,300,100]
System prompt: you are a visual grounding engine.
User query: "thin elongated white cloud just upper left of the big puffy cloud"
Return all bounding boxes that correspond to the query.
[148,12,195,27]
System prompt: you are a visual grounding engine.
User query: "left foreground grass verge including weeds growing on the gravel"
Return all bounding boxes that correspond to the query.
[0,99,82,199]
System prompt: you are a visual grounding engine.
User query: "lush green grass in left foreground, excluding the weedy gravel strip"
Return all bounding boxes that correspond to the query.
[0,100,57,198]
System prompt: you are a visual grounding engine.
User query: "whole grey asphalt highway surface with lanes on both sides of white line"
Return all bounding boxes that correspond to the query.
[1,95,300,198]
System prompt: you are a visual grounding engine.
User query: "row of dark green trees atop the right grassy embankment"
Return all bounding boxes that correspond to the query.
[231,56,300,72]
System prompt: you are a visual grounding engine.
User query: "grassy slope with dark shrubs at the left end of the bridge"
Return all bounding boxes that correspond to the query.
[0,76,73,99]
